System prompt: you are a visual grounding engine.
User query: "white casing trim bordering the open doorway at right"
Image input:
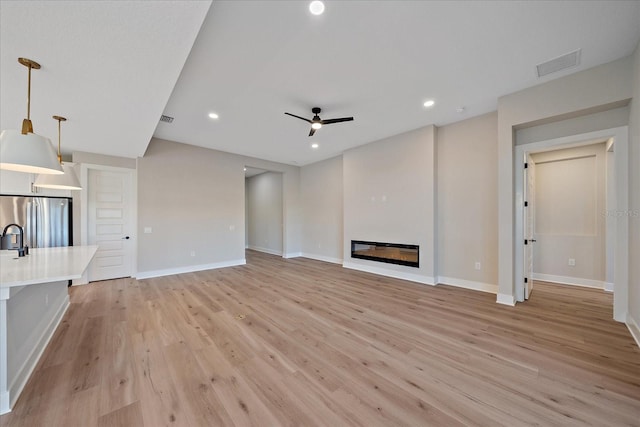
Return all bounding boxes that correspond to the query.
[511,126,629,322]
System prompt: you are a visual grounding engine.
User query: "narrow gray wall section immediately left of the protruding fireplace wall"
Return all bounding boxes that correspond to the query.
[300,156,344,263]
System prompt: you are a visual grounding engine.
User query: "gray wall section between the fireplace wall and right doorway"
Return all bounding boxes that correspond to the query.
[437,113,498,292]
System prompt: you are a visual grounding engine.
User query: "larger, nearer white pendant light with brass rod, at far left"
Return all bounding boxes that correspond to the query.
[0,58,63,174]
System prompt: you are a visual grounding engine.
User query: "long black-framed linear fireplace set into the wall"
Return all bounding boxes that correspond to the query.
[351,240,420,267]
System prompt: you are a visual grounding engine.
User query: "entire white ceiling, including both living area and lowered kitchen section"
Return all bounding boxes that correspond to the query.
[0,1,640,165]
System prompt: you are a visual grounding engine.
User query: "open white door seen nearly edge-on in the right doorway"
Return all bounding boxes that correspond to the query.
[524,153,536,299]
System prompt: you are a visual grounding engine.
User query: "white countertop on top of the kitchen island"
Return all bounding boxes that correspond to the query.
[0,246,98,288]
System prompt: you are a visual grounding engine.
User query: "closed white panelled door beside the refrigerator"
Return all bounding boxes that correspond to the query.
[87,169,135,281]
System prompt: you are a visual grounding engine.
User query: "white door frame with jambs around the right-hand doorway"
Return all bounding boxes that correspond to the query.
[514,127,629,322]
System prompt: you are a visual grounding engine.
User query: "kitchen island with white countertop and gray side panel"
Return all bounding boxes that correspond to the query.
[0,246,98,414]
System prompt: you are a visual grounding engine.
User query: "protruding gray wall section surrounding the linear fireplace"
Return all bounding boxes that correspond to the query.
[343,126,436,283]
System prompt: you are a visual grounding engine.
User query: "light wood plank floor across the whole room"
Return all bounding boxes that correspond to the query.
[0,251,640,427]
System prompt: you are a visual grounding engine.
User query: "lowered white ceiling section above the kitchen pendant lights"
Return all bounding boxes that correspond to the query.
[0,0,211,158]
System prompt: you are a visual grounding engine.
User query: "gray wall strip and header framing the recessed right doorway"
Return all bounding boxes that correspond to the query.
[498,57,633,304]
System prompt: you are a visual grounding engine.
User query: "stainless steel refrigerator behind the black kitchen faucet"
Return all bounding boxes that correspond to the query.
[0,195,73,248]
